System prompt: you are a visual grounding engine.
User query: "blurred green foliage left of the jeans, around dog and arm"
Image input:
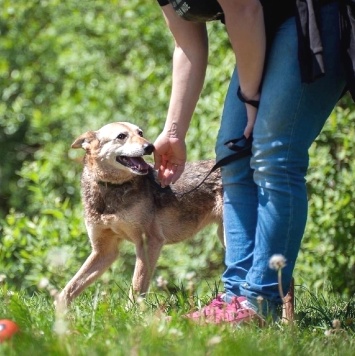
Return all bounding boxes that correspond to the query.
[0,0,233,291]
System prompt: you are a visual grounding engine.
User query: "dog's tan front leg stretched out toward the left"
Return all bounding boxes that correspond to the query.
[56,231,120,306]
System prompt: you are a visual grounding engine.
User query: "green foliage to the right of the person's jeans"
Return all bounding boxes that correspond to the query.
[297,98,355,295]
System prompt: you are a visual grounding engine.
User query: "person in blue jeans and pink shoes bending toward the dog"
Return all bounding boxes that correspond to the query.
[154,0,354,323]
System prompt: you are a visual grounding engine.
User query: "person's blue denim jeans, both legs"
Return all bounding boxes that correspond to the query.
[216,3,345,314]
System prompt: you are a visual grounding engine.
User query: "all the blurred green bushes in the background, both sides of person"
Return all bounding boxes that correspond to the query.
[0,0,355,296]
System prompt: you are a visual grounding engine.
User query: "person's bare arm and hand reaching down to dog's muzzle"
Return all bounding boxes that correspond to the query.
[154,5,208,186]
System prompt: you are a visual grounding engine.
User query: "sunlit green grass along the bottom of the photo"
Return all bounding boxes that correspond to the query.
[0,283,355,356]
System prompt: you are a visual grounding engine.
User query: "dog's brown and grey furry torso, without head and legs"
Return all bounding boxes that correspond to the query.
[82,160,222,244]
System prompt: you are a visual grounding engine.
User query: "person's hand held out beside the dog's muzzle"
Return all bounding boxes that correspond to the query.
[154,132,186,188]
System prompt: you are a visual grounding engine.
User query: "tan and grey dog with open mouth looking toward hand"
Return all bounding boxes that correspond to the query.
[57,122,224,305]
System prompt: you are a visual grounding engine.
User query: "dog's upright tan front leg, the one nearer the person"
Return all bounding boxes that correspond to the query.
[130,236,164,301]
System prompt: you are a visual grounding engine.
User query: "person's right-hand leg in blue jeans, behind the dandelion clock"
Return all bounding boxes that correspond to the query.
[242,3,345,314]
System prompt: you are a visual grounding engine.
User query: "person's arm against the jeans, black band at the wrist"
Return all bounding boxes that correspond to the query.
[218,0,266,137]
